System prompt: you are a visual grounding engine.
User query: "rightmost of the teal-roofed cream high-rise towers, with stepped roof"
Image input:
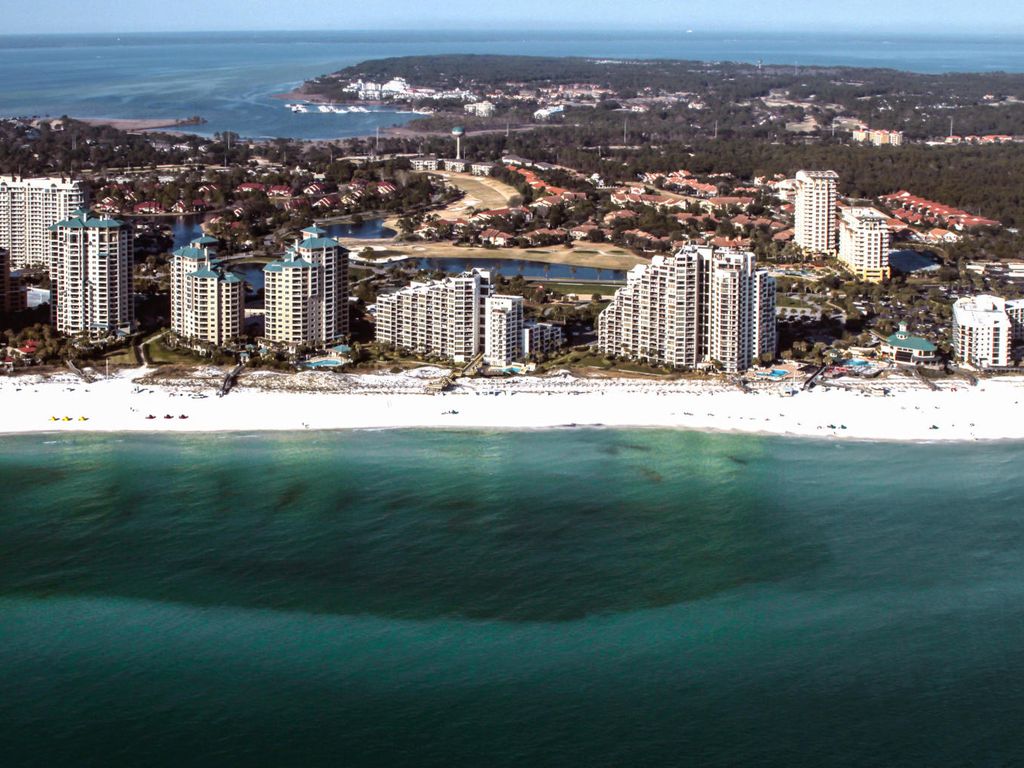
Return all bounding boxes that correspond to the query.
[263,226,348,348]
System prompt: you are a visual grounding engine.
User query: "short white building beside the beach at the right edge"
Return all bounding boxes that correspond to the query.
[953,296,1024,370]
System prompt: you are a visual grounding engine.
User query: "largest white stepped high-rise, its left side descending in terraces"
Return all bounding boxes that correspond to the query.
[597,246,775,373]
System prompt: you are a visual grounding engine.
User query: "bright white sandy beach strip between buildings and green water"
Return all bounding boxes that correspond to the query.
[0,369,1024,441]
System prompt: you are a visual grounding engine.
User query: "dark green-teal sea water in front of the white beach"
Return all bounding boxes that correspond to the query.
[6,430,1024,768]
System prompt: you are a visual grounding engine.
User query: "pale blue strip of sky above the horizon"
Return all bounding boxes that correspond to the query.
[0,0,1024,37]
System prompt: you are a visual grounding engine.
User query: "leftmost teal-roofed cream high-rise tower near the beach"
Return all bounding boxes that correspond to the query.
[49,211,135,338]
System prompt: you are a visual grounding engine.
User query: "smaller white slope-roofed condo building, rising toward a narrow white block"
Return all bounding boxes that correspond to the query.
[376,269,490,362]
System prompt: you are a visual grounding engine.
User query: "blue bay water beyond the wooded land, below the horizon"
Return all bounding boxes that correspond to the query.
[0,30,1024,138]
